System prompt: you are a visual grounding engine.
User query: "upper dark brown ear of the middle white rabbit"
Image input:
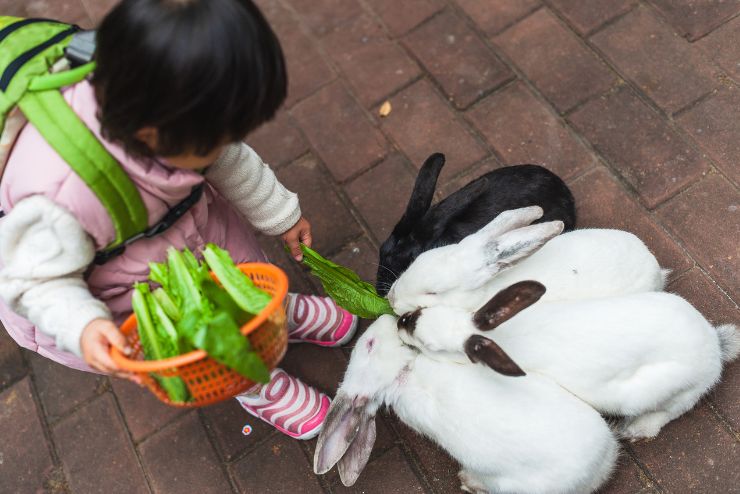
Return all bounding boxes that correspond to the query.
[473,281,546,331]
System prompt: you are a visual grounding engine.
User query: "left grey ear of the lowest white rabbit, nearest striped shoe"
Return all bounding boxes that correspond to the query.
[313,391,367,475]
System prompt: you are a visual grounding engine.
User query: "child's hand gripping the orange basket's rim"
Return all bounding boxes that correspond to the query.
[80,319,135,380]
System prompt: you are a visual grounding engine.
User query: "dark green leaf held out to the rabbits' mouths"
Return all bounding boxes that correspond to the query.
[301,244,394,319]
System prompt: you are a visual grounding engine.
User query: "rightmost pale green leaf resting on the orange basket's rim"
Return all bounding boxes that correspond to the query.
[203,244,272,315]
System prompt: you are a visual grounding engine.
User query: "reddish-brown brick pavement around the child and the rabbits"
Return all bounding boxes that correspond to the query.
[0,0,740,494]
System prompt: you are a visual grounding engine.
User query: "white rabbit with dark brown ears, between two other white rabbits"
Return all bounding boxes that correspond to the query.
[398,281,740,439]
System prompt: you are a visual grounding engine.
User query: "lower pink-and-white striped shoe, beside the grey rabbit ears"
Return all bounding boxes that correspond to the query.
[236,369,331,439]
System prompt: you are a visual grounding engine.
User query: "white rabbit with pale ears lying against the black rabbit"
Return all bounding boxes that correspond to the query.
[388,206,667,314]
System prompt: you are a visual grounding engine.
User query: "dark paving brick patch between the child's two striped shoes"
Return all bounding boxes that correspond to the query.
[280,343,347,397]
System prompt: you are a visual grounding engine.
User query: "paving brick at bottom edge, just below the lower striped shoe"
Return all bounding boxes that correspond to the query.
[231,434,323,494]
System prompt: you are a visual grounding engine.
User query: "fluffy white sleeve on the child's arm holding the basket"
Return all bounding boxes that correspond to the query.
[0,196,111,356]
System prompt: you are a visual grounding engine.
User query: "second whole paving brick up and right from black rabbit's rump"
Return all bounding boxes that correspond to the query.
[569,86,709,208]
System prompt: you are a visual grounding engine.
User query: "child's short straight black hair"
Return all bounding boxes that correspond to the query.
[93,0,287,156]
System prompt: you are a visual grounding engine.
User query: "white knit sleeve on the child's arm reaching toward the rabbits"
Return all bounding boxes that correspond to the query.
[206,143,301,235]
